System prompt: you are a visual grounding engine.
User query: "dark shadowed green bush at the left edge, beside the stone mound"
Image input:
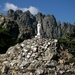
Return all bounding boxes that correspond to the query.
[0,25,15,54]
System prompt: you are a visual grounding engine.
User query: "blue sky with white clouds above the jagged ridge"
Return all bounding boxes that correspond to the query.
[0,0,75,24]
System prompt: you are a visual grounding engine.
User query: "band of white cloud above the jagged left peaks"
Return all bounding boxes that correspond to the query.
[4,2,39,15]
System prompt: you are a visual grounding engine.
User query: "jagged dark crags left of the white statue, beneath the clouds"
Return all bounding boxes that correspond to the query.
[7,9,36,38]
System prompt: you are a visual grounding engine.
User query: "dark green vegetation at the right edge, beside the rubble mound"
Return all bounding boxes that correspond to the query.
[58,26,75,56]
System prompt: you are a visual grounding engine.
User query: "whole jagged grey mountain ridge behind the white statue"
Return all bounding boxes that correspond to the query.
[0,9,73,38]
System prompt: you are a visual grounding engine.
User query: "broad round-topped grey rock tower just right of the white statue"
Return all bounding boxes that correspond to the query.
[43,15,57,38]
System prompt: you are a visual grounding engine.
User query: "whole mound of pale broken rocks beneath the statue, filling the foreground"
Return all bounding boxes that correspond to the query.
[0,38,75,75]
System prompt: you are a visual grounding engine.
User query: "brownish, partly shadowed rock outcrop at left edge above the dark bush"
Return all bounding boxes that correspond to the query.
[0,14,19,38]
